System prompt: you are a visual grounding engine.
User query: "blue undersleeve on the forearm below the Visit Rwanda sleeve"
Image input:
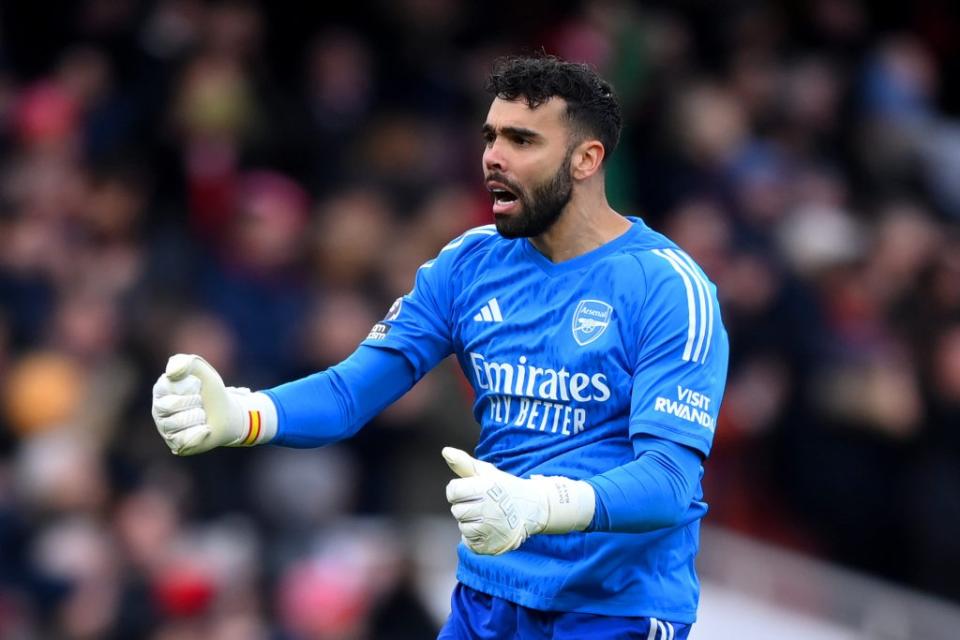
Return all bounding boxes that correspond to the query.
[587,436,703,533]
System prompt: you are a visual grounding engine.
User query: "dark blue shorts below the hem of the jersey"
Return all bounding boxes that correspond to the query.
[437,584,690,640]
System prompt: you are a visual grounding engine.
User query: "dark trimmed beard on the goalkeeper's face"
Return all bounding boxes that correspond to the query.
[495,149,573,238]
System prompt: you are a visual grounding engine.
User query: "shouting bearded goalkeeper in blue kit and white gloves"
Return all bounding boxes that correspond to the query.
[153,57,728,640]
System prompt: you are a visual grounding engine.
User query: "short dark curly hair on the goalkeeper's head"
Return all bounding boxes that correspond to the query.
[486,55,623,160]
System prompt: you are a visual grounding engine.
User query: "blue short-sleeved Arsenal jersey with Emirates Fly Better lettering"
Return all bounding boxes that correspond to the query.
[363,218,728,623]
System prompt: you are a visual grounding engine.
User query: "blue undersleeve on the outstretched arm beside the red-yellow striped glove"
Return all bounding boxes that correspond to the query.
[265,345,416,447]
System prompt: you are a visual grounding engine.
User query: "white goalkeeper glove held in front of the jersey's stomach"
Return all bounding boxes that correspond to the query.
[443,447,596,555]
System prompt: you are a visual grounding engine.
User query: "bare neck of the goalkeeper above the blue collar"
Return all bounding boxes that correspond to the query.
[530,198,630,263]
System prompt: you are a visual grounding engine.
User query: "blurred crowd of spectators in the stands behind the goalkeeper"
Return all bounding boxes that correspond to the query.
[0,0,960,640]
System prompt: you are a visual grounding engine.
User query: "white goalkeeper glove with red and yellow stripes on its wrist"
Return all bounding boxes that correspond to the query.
[152,353,277,456]
